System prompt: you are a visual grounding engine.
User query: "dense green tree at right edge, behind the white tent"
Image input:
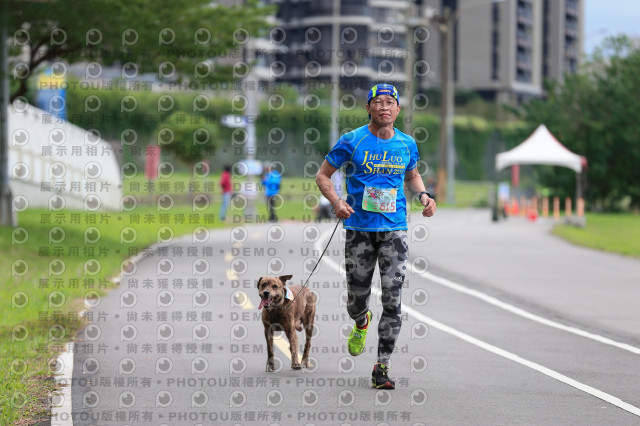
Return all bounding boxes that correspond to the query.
[524,36,640,210]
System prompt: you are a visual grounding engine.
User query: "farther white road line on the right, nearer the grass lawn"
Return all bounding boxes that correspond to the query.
[418,272,640,355]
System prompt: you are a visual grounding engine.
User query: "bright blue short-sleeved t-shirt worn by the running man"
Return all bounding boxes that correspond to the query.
[325,125,420,232]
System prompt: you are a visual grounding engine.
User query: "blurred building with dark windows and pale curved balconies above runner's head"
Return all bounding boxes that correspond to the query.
[271,0,410,91]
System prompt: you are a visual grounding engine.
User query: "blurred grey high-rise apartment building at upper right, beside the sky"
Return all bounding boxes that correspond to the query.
[418,0,584,104]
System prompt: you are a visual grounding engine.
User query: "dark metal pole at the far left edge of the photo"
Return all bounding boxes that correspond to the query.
[0,1,17,227]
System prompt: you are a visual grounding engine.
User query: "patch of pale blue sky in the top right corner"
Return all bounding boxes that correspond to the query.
[584,0,640,54]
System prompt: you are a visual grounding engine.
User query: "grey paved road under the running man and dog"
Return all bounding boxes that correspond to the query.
[66,209,640,425]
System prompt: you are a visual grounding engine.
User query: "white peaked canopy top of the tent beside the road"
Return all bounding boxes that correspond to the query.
[496,124,586,173]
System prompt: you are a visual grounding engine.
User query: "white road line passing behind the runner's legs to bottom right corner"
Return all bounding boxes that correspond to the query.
[315,233,640,416]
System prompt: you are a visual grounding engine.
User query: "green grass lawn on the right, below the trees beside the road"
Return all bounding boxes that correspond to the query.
[553,213,640,258]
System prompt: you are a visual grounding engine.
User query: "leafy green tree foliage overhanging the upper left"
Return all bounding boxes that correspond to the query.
[8,0,272,100]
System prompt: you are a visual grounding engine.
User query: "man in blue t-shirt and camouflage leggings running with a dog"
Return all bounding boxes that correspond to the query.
[316,84,436,389]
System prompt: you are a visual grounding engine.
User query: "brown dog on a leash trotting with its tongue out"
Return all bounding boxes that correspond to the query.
[258,275,316,372]
